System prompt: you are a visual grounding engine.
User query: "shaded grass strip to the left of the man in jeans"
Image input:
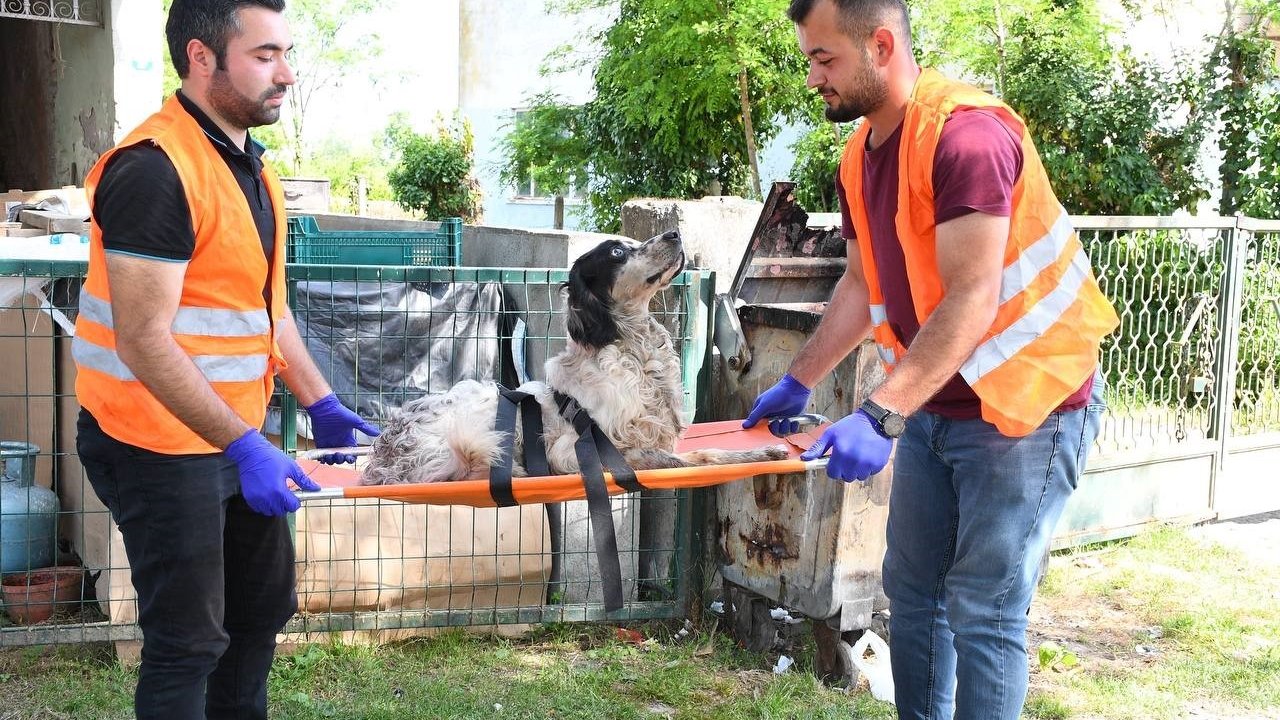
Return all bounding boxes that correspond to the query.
[0,624,893,720]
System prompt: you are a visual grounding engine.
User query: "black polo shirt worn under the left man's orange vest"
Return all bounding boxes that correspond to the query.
[93,91,275,261]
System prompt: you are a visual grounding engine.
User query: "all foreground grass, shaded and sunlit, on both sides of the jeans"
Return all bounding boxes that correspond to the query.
[0,520,1280,720]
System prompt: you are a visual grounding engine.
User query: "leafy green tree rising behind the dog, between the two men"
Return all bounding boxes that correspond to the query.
[502,0,812,231]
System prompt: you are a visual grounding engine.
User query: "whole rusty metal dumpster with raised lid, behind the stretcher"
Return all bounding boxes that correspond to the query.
[710,182,891,685]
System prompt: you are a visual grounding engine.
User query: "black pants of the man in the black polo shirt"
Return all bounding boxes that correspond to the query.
[76,410,297,720]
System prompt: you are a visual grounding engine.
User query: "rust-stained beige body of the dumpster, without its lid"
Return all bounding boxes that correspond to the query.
[712,320,892,630]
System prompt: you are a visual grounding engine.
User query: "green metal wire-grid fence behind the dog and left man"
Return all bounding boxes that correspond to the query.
[0,261,714,646]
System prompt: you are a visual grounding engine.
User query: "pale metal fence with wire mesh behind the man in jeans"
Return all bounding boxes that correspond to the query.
[1055,217,1280,547]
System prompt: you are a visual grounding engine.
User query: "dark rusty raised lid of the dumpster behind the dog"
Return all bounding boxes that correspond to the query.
[730,181,846,332]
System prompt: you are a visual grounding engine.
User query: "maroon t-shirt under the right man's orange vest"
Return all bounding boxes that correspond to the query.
[836,109,1093,420]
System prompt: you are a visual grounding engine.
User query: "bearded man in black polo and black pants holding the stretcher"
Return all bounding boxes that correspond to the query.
[73,0,378,720]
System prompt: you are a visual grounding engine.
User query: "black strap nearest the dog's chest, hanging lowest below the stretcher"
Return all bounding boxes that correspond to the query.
[556,392,644,611]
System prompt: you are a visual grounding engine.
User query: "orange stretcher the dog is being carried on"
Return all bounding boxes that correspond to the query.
[296,420,827,507]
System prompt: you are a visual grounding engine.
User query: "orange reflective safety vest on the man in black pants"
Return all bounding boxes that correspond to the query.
[72,96,285,455]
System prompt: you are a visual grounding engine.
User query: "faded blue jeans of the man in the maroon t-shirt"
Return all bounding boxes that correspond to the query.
[883,377,1106,720]
